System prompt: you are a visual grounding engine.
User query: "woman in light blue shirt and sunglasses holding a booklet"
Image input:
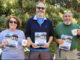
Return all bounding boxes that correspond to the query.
[0,16,25,60]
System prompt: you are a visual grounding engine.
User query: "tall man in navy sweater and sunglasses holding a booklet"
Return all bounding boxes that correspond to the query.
[25,2,53,60]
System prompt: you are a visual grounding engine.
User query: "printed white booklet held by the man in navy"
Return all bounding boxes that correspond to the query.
[35,32,47,47]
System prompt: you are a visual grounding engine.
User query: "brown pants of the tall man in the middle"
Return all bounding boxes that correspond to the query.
[29,51,50,60]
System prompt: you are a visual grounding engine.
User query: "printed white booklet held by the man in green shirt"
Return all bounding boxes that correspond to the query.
[59,34,72,50]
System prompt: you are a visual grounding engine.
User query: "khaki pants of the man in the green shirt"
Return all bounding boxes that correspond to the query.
[56,49,78,60]
